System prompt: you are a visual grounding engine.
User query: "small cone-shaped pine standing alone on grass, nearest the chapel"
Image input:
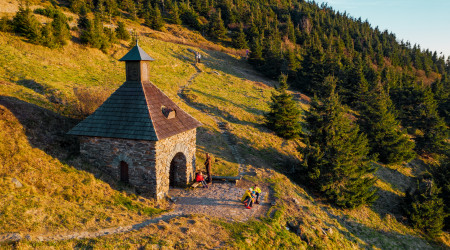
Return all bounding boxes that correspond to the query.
[265,75,301,139]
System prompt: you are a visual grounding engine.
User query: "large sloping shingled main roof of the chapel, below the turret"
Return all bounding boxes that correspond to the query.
[69,82,202,141]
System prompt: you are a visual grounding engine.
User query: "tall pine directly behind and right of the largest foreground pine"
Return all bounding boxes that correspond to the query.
[358,84,414,164]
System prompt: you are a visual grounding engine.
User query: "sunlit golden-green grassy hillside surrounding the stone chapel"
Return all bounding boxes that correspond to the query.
[0,4,449,249]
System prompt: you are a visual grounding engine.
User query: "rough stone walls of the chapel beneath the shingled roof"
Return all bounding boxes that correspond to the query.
[80,129,196,199]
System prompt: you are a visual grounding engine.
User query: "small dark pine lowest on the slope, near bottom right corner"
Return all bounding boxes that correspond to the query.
[406,177,446,238]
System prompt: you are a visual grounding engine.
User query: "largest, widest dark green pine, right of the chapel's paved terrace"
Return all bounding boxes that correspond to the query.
[303,83,377,208]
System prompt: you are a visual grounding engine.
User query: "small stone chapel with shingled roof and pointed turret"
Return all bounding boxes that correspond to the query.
[68,42,202,200]
